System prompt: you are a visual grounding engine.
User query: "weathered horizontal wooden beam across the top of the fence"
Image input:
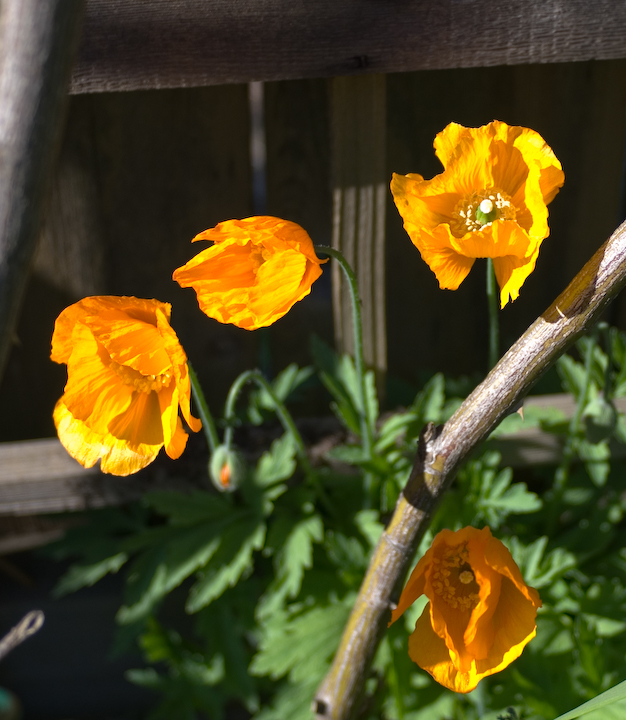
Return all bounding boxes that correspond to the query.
[71,0,626,93]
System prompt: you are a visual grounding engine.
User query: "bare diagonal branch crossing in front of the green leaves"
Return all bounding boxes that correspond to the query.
[313,223,626,720]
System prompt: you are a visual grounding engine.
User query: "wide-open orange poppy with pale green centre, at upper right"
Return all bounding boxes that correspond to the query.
[391,120,565,307]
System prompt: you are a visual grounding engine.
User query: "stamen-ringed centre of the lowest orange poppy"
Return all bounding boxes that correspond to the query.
[432,545,479,610]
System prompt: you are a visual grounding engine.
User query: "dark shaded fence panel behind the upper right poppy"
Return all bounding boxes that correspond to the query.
[387,60,626,380]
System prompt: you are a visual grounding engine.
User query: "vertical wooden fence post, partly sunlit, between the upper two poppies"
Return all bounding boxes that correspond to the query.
[331,75,389,387]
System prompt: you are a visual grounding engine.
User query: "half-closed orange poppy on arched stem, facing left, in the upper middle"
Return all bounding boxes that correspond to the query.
[173,216,326,330]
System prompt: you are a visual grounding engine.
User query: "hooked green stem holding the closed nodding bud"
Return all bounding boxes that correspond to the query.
[224,370,335,515]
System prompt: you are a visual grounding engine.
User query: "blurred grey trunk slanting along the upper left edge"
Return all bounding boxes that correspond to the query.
[0,0,84,377]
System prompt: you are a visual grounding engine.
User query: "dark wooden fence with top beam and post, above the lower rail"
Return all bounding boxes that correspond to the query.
[0,0,626,540]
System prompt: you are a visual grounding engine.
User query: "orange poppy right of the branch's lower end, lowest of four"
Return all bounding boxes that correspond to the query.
[389,527,541,693]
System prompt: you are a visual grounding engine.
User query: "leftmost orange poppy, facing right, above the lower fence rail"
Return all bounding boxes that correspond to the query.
[51,296,202,475]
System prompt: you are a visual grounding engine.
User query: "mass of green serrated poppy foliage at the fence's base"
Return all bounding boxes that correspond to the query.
[50,328,626,720]
